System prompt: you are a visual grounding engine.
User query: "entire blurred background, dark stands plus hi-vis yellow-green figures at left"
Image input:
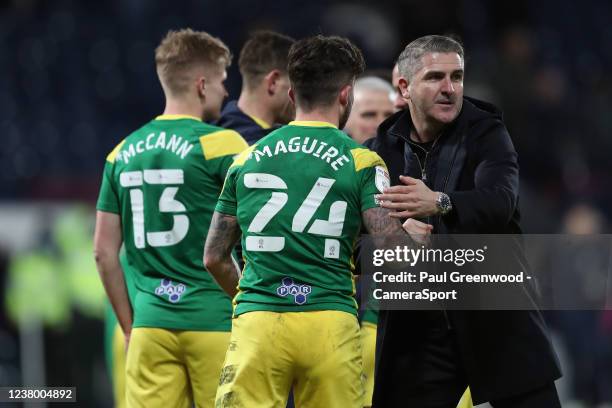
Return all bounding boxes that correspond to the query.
[0,0,612,407]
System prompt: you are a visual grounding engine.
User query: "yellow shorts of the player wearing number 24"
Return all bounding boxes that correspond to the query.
[215,310,364,408]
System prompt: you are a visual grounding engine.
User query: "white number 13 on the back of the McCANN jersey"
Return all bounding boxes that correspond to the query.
[119,169,189,248]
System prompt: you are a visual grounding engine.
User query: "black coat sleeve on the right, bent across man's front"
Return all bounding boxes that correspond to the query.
[442,121,519,233]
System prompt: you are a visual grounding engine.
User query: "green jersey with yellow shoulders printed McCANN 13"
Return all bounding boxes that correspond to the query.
[97,115,248,331]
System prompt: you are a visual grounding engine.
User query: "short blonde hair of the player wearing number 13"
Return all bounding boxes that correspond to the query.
[155,28,232,95]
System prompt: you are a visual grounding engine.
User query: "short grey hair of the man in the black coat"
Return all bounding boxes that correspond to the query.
[397,35,464,80]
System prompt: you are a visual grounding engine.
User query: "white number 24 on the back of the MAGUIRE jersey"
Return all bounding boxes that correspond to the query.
[244,173,347,258]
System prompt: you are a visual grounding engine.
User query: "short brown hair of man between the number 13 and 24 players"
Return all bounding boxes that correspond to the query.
[238,30,295,88]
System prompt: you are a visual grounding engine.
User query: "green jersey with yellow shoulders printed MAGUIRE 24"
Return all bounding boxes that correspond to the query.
[216,121,389,315]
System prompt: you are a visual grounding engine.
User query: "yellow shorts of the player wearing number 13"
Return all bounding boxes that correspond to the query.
[126,328,230,408]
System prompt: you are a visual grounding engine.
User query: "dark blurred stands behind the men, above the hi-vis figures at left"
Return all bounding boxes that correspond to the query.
[0,0,612,232]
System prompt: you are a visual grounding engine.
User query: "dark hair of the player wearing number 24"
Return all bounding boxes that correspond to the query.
[287,35,365,111]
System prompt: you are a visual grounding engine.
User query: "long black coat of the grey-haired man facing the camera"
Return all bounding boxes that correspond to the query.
[366,97,561,408]
